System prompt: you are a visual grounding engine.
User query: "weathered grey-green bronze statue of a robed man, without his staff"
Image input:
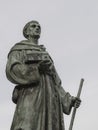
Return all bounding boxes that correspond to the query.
[6,21,81,130]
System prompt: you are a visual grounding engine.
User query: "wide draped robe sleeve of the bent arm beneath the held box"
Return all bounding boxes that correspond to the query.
[6,51,40,85]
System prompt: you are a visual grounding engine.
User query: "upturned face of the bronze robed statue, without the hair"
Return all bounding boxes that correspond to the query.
[27,22,41,38]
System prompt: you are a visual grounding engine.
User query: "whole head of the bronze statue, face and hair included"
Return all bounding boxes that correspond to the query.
[23,20,41,39]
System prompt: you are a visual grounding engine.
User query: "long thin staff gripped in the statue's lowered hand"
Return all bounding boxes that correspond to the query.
[69,79,84,130]
